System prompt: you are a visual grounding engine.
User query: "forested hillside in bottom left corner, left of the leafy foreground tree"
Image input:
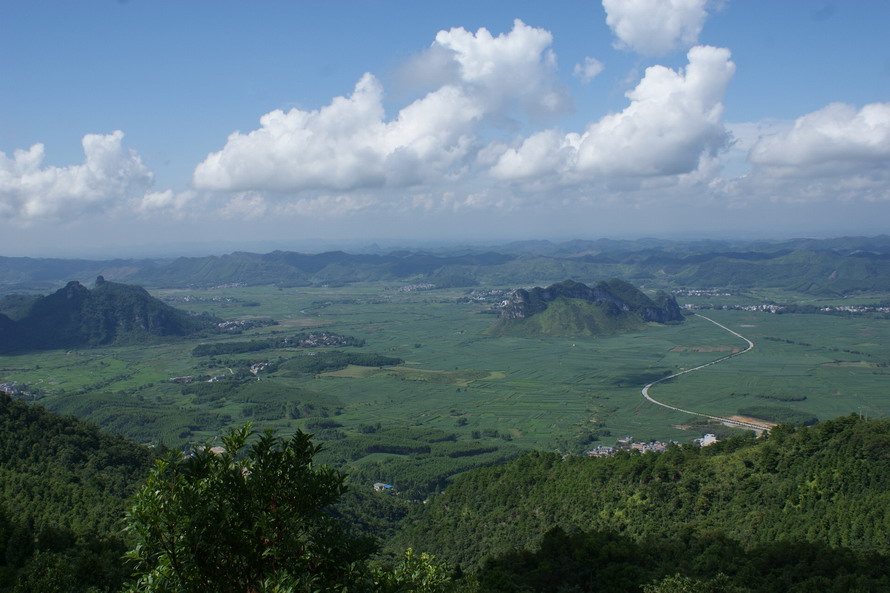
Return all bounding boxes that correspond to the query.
[0,393,154,592]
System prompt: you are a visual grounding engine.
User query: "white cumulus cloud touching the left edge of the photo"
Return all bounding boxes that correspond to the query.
[0,130,152,222]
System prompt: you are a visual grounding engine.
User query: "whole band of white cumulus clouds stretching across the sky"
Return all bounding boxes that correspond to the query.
[0,11,890,232]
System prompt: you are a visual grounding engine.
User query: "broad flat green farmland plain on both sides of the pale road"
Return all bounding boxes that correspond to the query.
[0,283,890,449]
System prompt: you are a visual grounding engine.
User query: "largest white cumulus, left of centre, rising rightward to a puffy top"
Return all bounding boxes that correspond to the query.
[193,20,569,194]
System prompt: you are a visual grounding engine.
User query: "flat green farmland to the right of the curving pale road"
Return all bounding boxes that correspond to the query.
[652,311,890,426]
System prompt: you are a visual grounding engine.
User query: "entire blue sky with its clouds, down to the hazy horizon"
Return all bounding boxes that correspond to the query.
[0,0,890,256]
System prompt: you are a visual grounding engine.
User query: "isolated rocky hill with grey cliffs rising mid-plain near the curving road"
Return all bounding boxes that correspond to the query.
[492,279,683,336]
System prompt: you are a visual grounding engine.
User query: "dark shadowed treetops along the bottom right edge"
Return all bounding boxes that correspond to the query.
[467,527,890,593]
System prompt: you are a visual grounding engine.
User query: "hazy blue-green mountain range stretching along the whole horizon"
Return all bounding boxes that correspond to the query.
[0,235,890,296]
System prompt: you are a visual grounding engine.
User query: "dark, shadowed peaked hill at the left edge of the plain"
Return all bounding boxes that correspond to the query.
[0,276,215,352]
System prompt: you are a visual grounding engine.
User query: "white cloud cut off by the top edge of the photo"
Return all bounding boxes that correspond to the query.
[603,0,708,55]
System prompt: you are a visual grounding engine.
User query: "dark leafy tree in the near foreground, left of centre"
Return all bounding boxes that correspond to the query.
[127,424,373,593]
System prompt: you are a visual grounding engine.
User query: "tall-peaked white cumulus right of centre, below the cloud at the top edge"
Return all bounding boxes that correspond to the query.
[491,46,735,181]
